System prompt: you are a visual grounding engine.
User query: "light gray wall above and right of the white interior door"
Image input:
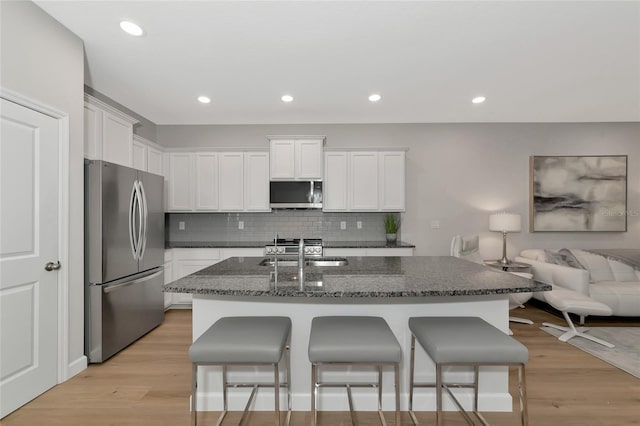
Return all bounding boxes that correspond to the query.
[0,1,84,370]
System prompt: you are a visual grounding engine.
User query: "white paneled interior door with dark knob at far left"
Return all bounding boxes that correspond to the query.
[0,99,64,417]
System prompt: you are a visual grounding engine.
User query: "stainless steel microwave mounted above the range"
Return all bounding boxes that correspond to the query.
[269,180,322,209]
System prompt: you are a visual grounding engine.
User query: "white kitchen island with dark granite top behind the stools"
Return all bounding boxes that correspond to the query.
[165,256,551,411]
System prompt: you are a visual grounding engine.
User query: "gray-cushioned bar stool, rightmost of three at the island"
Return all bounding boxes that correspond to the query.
[409,317,529,426]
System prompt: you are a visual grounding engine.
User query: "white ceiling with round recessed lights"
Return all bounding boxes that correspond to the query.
[36,0,640,124]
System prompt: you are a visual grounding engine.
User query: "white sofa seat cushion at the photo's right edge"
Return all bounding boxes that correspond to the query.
[589,281,640,317]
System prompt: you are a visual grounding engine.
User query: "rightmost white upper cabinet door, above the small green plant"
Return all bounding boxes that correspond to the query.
[378,151,406,211]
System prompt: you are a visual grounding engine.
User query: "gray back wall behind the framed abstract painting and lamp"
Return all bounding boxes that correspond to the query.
[157,123,640,258]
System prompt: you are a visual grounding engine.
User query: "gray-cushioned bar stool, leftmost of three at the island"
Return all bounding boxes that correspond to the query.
[189,317,291,426]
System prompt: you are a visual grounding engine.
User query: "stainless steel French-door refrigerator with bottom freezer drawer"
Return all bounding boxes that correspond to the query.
[85,160,164,363]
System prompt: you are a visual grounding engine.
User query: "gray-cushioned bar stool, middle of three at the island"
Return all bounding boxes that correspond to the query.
[309,316,402,426]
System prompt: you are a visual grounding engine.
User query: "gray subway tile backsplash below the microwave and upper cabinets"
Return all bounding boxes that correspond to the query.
[165,210,399,242]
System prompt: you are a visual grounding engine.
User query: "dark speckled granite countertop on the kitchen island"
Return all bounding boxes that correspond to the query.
[164,256,551,302]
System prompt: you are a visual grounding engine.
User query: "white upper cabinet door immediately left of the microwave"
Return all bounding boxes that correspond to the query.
[244,152,271,212]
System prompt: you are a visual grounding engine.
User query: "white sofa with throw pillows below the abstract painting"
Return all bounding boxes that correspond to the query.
[515,249,640,317]
